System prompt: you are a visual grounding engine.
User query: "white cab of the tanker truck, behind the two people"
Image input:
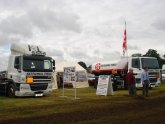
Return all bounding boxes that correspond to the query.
[128,57,160,87]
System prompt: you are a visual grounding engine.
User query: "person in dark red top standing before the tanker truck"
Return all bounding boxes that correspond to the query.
[127,68,136,96]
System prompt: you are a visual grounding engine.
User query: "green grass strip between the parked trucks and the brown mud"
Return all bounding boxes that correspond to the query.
[0,84,165,122]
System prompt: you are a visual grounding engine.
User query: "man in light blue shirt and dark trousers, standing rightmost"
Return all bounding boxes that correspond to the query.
[141,67,150,97]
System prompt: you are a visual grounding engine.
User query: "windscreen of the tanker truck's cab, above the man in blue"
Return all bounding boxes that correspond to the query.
[141,58,159,69]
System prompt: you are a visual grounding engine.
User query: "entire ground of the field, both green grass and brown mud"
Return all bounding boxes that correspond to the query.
[0,84,165,124]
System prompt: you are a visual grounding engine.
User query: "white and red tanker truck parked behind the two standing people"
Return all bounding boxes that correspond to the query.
[92,56,160,90]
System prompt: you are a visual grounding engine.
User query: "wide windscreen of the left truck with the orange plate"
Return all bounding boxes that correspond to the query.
[23,56,52,72]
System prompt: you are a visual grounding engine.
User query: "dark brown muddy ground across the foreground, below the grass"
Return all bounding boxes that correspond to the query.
[0,93,165,124]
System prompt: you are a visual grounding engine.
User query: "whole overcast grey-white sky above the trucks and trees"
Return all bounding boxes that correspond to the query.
[0,0,165,70]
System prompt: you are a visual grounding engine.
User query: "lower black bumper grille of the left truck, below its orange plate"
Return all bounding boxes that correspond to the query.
[30,83,48,91]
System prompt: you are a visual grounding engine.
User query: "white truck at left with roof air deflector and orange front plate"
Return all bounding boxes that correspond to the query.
[0,43,55,97]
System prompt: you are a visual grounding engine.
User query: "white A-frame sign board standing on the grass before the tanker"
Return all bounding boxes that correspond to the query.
[96,75,113,96]
